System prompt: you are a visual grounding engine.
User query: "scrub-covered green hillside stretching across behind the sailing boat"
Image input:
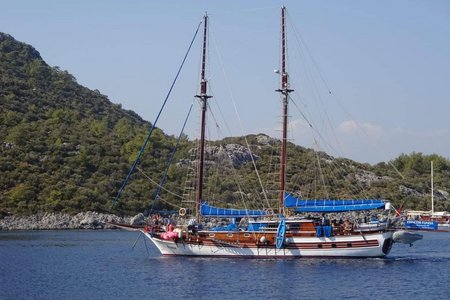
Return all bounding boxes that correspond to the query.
[0,33,450,215]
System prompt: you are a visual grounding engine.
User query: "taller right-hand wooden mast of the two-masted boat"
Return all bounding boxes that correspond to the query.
[276,6,294,215]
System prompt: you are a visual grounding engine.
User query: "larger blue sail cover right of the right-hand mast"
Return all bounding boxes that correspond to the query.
[284,193,385,212]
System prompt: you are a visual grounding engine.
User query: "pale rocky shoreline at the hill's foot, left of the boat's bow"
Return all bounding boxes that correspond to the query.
[0,211,144,231]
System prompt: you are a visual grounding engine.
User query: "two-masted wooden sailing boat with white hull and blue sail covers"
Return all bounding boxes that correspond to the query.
[129,7,412,258]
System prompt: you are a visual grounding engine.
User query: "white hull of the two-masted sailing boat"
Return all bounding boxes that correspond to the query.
[143,231,392,258]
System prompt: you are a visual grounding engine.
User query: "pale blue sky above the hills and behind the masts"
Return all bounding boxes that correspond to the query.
[0,0,450,164]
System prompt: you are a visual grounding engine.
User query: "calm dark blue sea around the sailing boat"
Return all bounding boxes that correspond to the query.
[0,230,450,300]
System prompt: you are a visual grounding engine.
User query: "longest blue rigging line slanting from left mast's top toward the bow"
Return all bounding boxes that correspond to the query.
[113,21,203,207]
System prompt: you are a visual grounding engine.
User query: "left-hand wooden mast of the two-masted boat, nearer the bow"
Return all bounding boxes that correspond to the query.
[195,14,211,220]
